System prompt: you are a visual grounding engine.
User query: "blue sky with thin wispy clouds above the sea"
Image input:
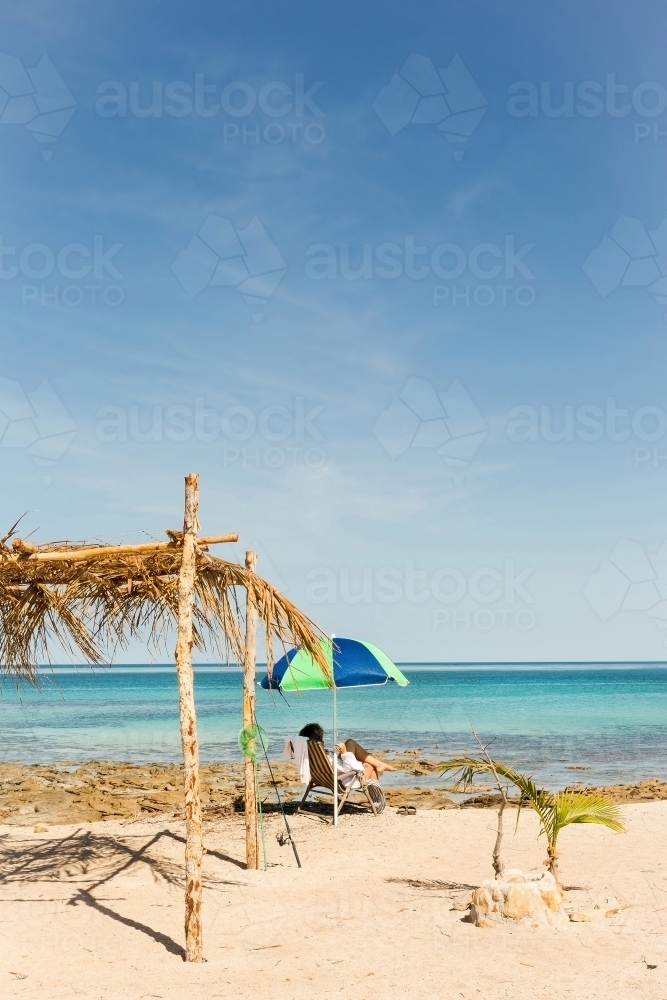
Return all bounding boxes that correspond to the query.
[0,0,667,661]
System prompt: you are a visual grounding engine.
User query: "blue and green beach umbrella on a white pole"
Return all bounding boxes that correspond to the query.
[262,636,409,825]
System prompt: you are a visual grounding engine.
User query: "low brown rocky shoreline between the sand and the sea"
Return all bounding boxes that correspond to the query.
[0,751,667,826]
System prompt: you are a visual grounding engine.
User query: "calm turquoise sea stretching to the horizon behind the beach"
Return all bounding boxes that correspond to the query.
[0,663,667,785]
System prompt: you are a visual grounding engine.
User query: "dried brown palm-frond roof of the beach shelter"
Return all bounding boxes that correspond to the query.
[0,526,329,683]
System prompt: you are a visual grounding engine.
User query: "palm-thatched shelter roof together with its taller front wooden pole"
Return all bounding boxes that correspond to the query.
[0,474,328,962]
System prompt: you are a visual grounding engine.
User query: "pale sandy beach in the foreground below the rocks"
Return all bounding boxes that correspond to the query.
[0,802,667,1000]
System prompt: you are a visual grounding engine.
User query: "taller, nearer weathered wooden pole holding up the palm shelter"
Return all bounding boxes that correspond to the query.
[176,473,204,962]
